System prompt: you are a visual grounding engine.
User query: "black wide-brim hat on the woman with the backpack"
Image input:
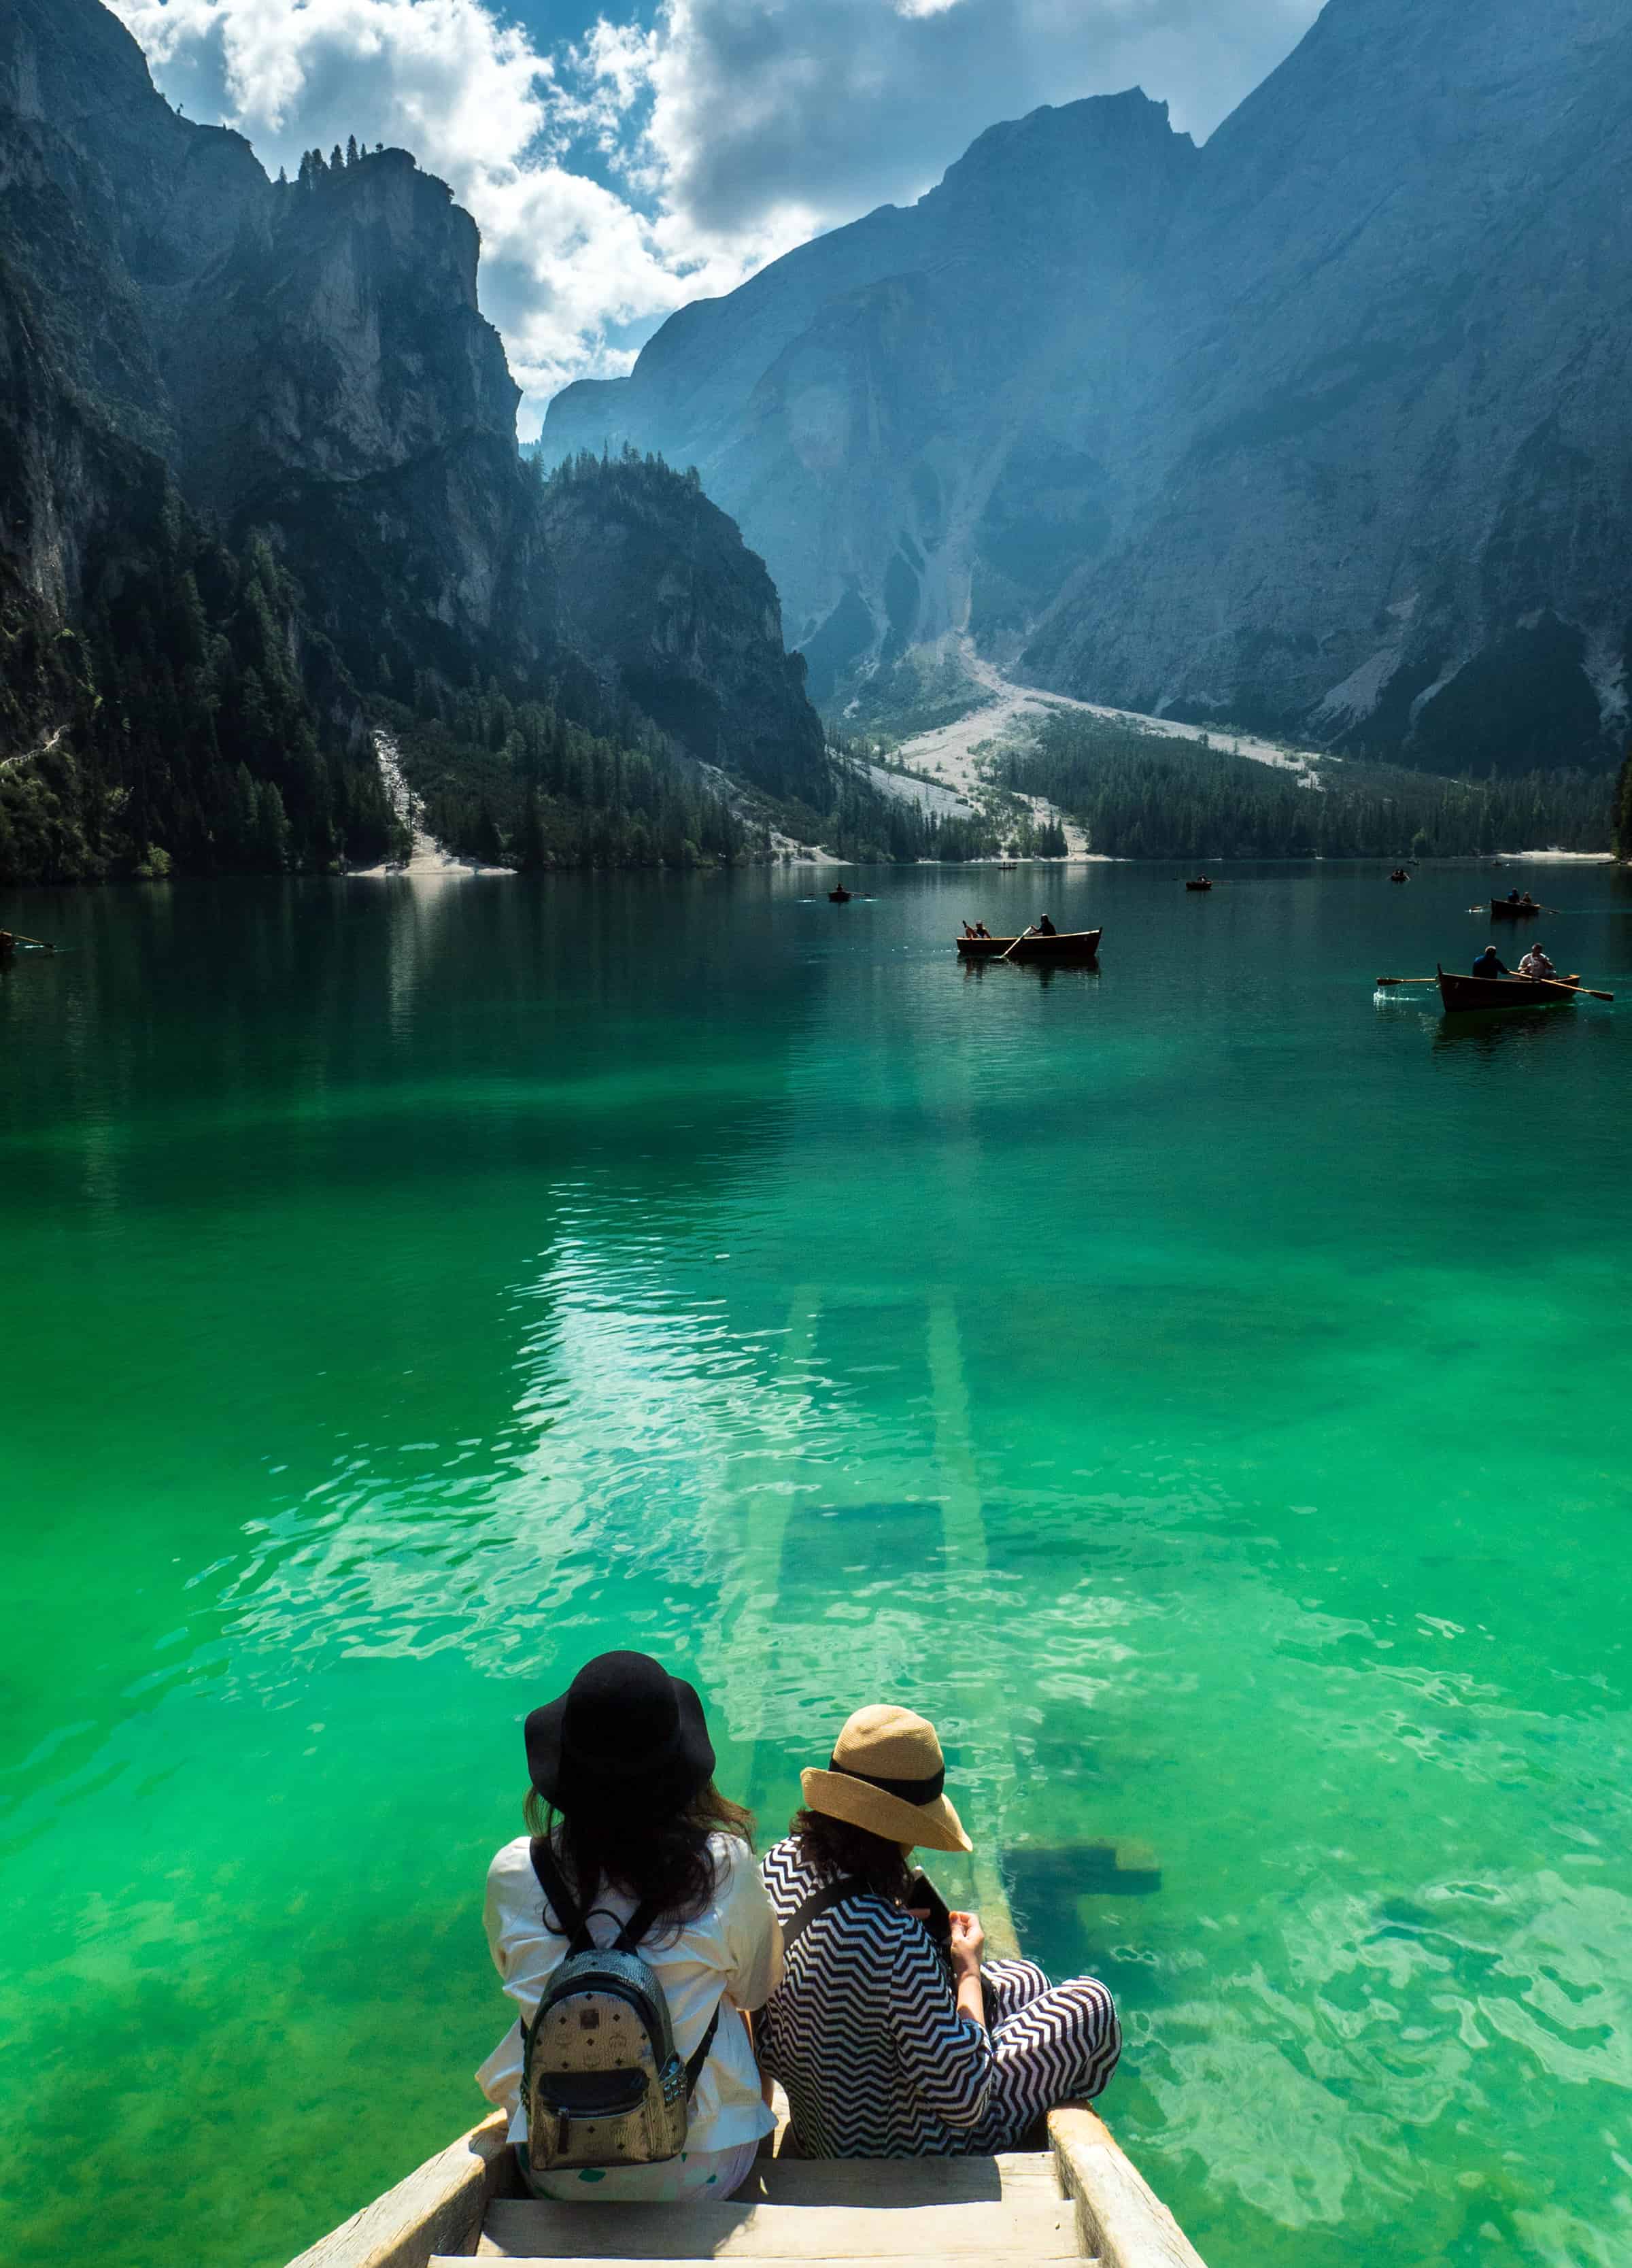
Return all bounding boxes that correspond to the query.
[526,1653,714,1814]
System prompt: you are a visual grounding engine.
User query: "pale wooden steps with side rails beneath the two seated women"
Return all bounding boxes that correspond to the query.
[290,2093,1204,2268]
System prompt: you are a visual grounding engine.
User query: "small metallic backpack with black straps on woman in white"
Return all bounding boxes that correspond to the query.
[522,1837,721,2173]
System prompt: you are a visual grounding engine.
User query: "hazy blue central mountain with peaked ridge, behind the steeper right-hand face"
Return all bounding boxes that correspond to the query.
[544,93,1197,698]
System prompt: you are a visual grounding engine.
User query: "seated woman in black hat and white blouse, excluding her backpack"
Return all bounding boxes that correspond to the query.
[476,1653,782,2202]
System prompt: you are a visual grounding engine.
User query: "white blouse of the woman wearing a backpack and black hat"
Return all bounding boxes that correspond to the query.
[476,1835,782,2150]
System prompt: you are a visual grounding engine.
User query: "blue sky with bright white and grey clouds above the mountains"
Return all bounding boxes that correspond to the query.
[111,0,1319,435]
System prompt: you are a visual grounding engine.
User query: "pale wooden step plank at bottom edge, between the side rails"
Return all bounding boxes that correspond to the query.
[478,2198,1079,2261]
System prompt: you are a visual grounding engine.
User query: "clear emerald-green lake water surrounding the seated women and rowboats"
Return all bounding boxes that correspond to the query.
[0,868,1632,2268]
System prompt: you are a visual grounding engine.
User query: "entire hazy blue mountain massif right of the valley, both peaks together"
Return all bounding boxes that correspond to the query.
[546,0,1632,766]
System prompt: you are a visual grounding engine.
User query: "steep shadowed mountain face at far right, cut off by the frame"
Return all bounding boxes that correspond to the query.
[1027,0,1632,769]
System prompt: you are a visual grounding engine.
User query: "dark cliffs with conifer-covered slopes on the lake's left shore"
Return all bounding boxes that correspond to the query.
[0,0,836,882]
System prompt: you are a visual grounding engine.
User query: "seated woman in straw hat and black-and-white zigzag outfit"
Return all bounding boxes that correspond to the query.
[760,1706,1122,2157]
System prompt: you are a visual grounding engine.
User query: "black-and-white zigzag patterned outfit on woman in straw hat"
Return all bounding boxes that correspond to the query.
[760,1837,1122,2157]
